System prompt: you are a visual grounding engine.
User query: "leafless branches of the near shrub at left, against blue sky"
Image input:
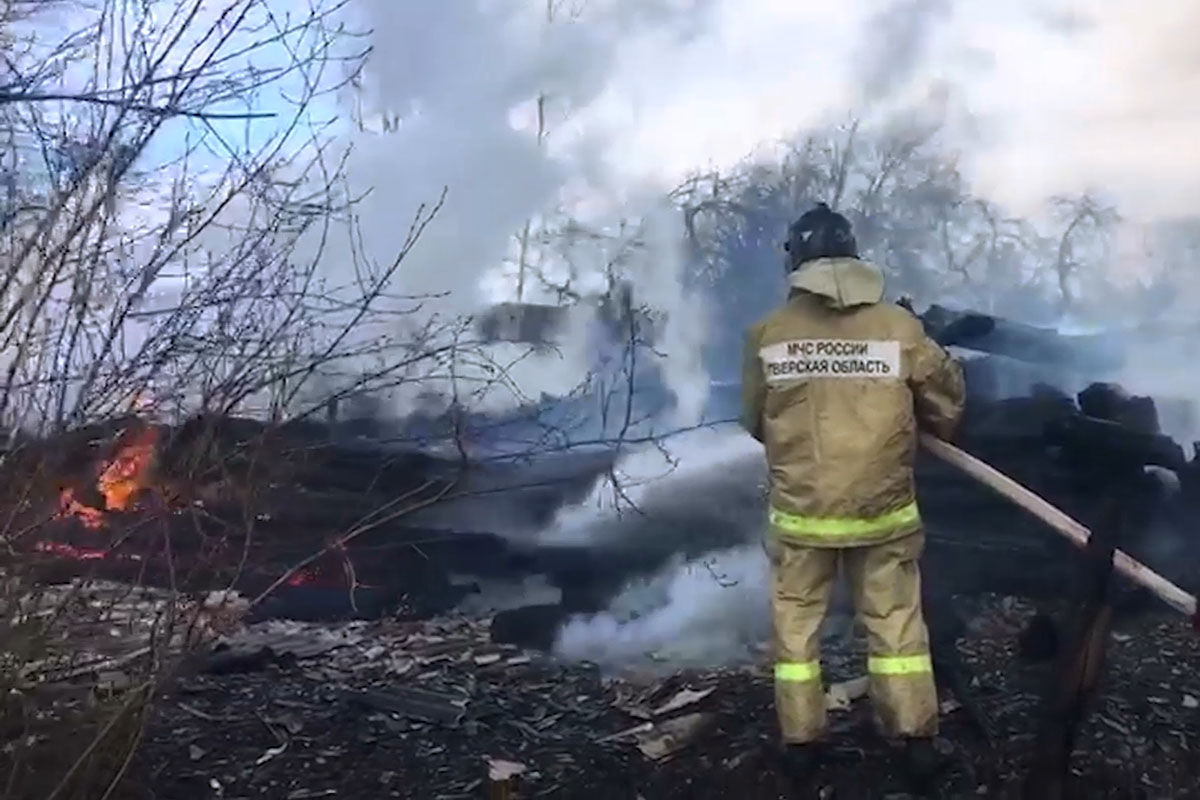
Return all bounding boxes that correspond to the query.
[0,0,506,441]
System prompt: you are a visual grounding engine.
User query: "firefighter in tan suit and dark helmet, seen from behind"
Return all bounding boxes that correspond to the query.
[742,203,964,783]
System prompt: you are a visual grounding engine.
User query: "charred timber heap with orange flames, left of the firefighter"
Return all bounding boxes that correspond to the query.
[0,417,612,619]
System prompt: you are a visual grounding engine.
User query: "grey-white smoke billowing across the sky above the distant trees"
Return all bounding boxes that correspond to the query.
[292,0,1200,423]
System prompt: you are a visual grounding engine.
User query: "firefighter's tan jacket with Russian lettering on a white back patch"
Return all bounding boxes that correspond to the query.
[742,258,964,547]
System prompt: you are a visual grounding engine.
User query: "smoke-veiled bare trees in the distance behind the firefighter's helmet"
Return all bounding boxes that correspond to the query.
[673,112,1118,378]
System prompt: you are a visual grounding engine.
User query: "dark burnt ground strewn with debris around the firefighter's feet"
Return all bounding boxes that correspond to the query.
[124,596,1200,800]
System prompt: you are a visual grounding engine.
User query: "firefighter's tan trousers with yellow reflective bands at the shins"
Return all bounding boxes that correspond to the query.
[768,533,937,744]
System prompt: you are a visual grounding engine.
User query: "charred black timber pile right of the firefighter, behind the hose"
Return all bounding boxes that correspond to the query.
[918,384,1200,602]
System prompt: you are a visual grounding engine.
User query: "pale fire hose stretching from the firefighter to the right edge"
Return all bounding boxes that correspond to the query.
[920,433,1200,630]
